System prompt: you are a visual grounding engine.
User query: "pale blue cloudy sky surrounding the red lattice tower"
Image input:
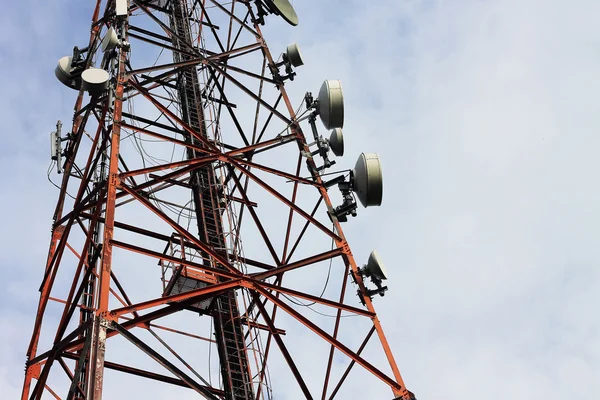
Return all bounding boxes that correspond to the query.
[0,0,600,400]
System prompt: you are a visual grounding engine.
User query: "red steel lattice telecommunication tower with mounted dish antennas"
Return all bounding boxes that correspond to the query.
[22,0,414,400]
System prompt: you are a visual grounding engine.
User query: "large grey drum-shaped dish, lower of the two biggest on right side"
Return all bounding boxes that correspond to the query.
[353,153,383,207]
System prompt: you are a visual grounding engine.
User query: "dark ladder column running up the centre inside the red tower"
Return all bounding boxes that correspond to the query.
[170,0,254,400]
